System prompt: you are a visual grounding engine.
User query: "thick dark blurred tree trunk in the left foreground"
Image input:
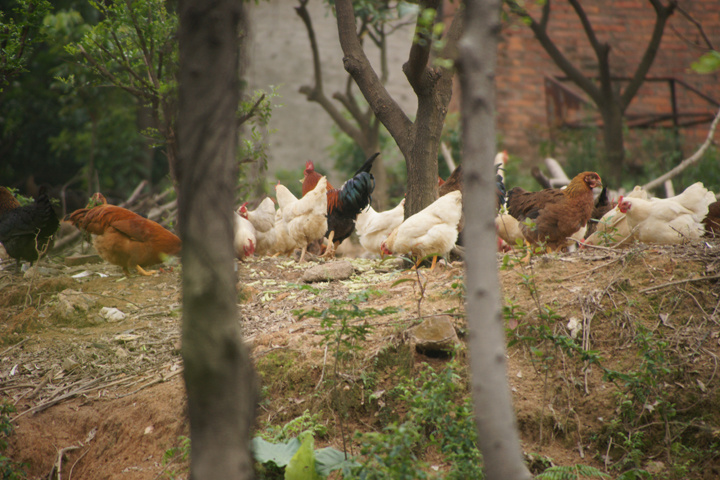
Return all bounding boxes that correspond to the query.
[177,0,257,480]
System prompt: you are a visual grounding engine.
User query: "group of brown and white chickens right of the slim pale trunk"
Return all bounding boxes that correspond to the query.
[495,172,720,250]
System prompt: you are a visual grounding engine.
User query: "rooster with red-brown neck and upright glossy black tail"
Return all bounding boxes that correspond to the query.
[303,153,379,256]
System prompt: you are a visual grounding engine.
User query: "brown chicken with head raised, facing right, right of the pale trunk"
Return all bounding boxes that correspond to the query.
[507,172,602,251]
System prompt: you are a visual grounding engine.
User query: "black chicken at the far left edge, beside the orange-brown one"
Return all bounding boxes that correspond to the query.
[0,188,60,272]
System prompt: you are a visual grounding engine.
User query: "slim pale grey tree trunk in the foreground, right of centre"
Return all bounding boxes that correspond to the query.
[459,0,531,480]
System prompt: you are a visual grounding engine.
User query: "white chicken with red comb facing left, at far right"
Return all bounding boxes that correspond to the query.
[618,182,715,244]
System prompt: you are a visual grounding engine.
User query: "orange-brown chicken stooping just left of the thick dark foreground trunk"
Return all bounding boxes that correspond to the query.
[65,193,182,276]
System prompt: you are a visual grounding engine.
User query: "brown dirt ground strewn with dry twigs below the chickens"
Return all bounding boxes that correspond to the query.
[0,241,720,479]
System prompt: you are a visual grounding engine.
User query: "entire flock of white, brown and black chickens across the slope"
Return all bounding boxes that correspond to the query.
[0,152,720,275]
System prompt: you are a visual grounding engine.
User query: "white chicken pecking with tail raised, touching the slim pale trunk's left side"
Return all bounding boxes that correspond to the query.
[380,190,462,270]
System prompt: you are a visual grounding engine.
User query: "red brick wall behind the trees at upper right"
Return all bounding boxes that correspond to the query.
[496,0,720,163]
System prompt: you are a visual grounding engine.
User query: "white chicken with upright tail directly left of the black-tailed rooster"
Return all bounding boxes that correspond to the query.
[275,177,327,262]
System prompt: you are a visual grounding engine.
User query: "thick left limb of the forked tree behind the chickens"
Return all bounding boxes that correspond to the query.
[335,0,413,153]
